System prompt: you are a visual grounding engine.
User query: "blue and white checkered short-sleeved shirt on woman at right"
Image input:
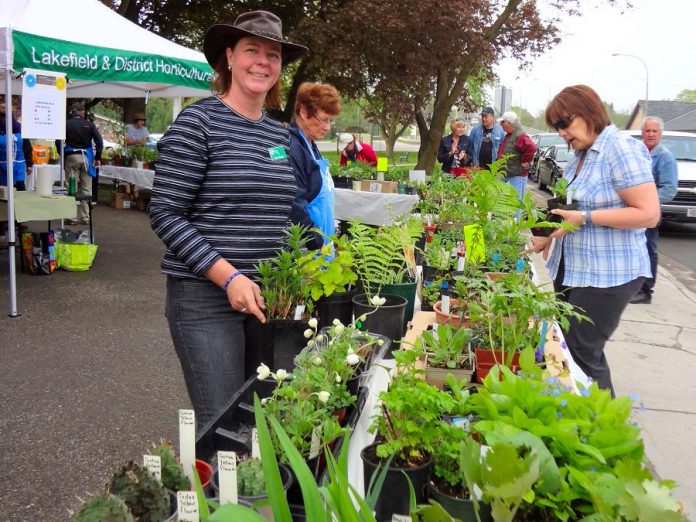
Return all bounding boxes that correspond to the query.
[546,125,654,288]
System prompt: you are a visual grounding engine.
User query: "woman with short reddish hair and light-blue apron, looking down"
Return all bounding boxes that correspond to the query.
[289,82,341,249]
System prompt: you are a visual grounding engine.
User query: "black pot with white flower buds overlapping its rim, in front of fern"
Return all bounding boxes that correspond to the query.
[353,294,407,359]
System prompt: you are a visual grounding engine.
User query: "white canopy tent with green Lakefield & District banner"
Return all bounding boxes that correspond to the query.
[0,0,213,317]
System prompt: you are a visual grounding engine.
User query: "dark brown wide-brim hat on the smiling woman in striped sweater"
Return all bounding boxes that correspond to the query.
[203,11,308,68]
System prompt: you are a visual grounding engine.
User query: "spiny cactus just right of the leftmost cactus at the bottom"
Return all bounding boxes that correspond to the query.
[107,461,169,522]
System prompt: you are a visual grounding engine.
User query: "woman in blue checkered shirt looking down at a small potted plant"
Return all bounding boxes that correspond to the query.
[532,85,660,394]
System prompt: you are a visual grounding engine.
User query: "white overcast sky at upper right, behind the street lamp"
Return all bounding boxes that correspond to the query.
[498,0,696,114]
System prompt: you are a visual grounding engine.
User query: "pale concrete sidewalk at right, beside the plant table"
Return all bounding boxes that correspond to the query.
[534,254,696,519]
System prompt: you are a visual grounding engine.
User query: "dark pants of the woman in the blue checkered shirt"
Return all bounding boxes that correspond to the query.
[553,262,645,397]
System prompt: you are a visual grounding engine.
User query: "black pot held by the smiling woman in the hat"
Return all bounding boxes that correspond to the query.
[244,316,309,379]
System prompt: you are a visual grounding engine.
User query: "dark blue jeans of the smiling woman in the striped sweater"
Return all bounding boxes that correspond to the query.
[165,276,248,429]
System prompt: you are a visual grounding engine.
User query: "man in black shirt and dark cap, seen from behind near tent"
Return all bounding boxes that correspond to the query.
[56,102,104,225]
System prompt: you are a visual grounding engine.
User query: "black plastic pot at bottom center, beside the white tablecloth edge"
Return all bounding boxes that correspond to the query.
[360,444,432,522]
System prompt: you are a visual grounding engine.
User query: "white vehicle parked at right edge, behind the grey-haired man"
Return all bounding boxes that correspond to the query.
[626,130,696,223]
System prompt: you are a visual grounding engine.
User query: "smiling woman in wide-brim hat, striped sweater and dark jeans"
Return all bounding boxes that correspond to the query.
[150,11,307,427]
